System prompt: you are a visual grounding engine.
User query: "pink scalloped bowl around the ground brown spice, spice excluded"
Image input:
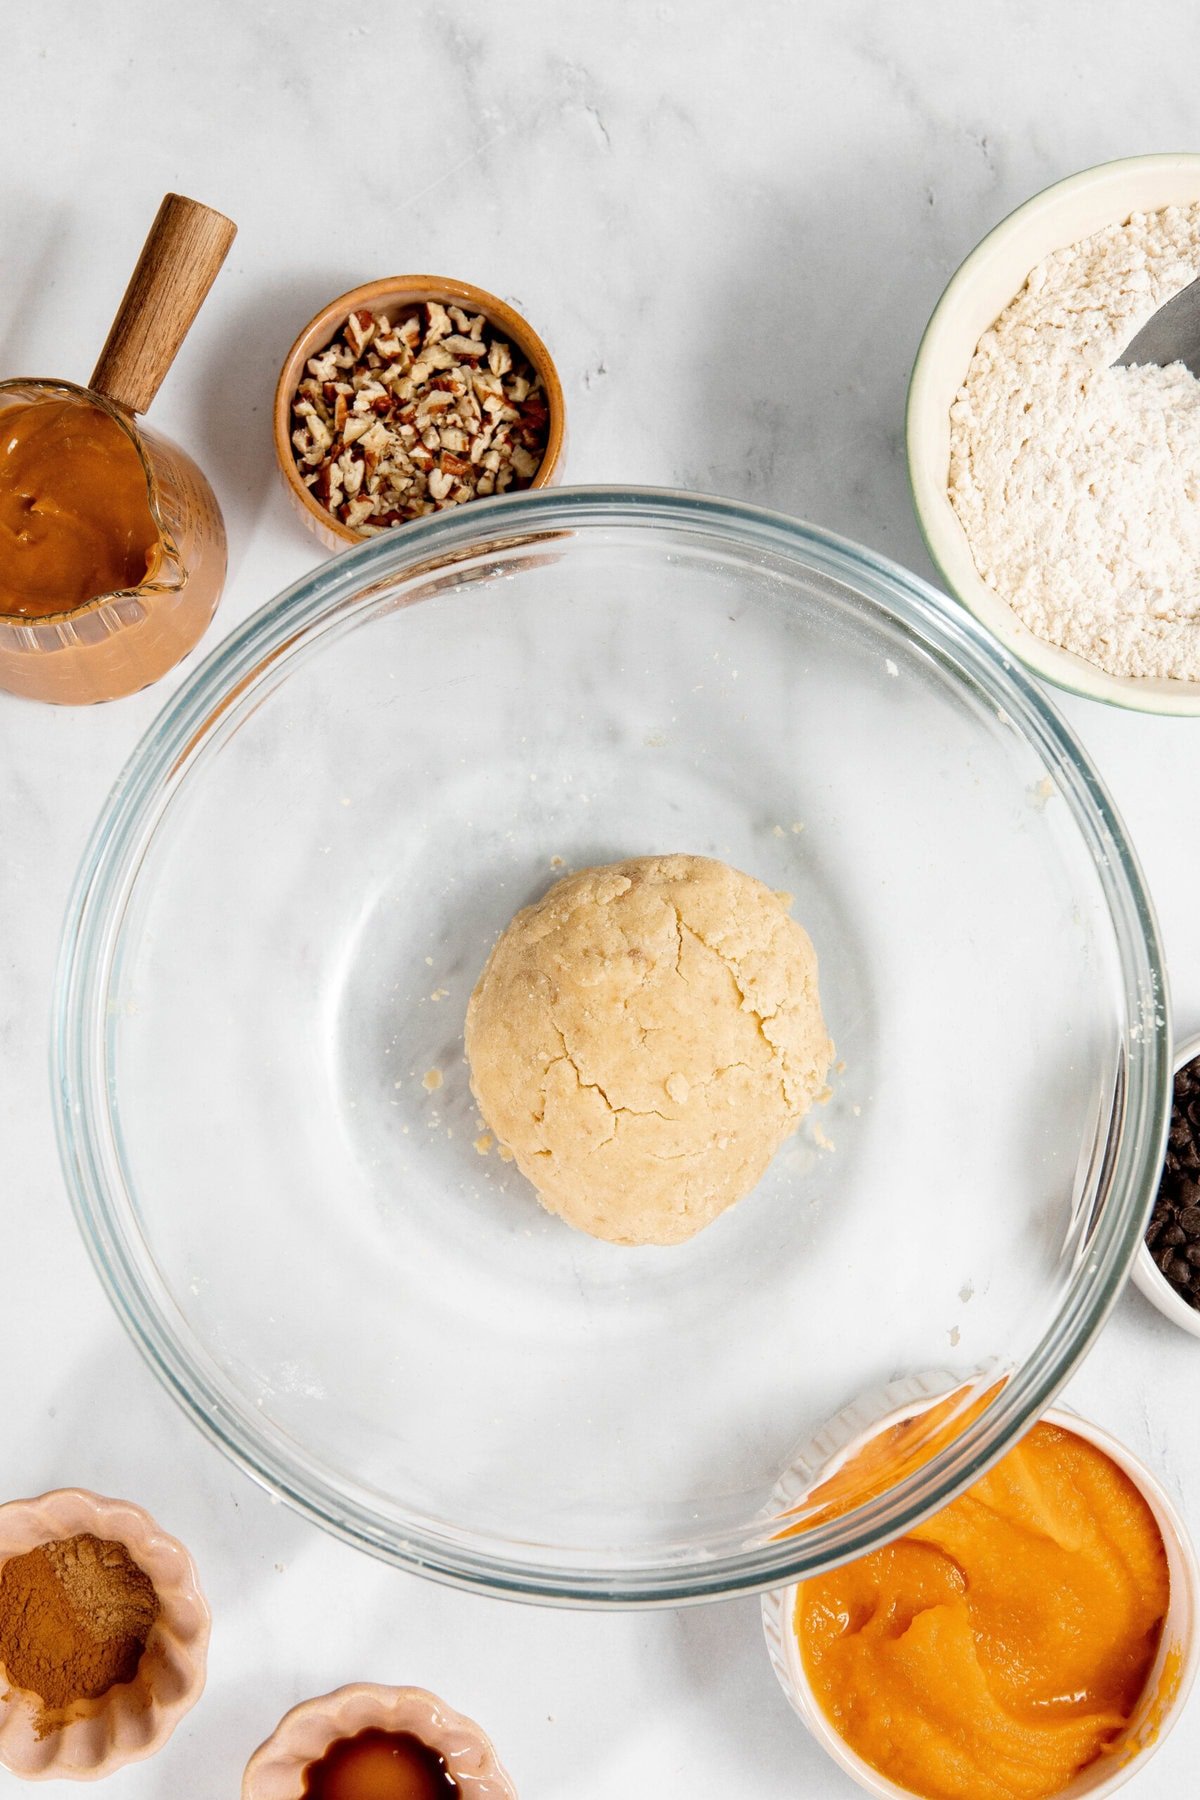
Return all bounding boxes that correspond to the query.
[0,1487,210,1782]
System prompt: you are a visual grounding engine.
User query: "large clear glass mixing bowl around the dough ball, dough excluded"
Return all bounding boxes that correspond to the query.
[56,490,1169,1604]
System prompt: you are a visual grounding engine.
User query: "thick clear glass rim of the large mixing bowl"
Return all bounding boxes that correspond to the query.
[50,486,1171,1607]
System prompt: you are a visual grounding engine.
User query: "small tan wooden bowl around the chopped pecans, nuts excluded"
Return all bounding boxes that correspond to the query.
[273,275,567,551]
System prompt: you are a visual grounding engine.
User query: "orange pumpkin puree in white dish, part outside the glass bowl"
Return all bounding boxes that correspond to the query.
[795,1424,1169,1800]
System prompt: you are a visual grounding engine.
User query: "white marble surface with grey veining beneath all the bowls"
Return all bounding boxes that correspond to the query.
[0,0,1200,1800]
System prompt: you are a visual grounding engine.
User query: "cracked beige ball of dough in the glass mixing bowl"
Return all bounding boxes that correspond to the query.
[466,855,833,1244]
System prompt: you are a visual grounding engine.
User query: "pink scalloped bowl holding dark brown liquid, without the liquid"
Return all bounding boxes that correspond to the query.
[241,1681,516,1800]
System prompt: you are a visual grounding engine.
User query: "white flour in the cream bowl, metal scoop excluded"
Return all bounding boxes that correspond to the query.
[950,205,1200,680]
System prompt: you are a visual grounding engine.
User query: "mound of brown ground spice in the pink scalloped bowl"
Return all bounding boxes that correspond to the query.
[0,1532,158,1710]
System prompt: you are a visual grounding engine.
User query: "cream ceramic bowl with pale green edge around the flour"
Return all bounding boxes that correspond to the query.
[907,155,1200,716]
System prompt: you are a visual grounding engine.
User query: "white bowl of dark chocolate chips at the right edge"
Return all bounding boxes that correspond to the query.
[1133,1031,1200,1337]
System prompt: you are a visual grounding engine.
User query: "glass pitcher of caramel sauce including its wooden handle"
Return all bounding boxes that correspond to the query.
[0,194,234,706]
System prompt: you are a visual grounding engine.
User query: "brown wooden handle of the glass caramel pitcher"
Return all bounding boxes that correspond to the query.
[90,194,237,412]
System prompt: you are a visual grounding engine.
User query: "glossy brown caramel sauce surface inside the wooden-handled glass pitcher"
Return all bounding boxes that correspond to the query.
[0,398,158,619]
